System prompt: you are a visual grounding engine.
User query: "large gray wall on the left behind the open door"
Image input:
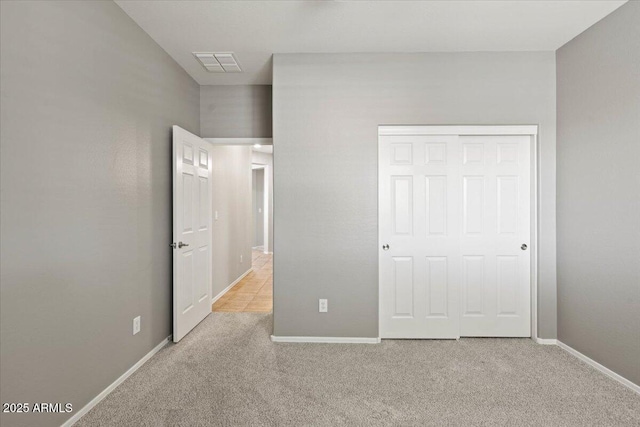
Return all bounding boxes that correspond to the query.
[0,1,200,426]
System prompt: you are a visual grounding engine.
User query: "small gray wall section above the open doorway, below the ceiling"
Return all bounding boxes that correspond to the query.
[200,85,271,138]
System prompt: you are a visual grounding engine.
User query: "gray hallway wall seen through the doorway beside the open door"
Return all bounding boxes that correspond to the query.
[212,145,253,296]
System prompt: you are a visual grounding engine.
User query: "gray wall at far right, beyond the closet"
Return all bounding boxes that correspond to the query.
[556,2,640,384]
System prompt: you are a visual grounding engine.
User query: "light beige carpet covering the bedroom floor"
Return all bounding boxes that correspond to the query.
[77,313,640,426]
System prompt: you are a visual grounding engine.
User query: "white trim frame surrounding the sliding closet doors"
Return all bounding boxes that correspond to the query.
[378,125,541,342]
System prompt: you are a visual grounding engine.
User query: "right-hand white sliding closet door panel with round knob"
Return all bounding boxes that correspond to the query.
[460,136,531,337]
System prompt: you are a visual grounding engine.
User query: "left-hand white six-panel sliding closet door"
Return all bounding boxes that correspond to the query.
[379,136,460,338]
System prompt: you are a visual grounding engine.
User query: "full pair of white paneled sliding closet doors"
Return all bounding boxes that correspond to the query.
[379,129,531,338]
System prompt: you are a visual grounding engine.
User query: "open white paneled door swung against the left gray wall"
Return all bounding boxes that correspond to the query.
[171,126,213,342]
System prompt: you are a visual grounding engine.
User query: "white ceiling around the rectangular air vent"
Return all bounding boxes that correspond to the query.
[116,0,625,85]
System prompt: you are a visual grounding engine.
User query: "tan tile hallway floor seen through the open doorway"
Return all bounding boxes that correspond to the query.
[212,250,273,313]
